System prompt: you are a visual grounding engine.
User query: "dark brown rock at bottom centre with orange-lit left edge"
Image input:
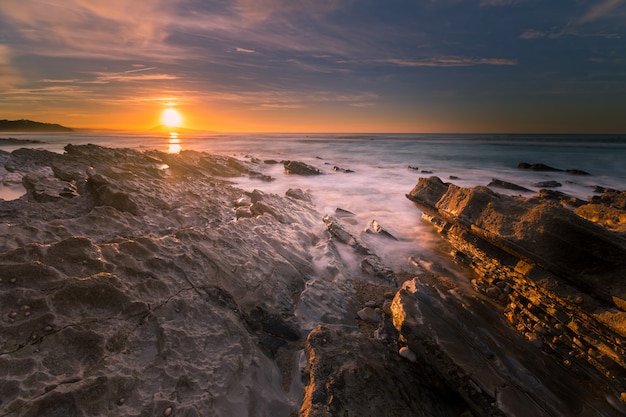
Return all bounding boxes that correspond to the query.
[300,325,476,417]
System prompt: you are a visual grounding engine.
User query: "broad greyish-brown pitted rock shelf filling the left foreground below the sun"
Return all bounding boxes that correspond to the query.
[0,145,316,417]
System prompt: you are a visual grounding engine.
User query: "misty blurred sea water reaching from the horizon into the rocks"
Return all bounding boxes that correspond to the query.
[0,132,626,264]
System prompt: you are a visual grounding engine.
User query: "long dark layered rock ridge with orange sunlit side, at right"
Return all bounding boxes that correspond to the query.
[404,177,626,406]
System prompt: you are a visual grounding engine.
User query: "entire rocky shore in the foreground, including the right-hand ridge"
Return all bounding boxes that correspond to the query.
[0,145,626,417]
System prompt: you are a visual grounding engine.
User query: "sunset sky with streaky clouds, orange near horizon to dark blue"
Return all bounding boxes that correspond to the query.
[0,0,626,133]
